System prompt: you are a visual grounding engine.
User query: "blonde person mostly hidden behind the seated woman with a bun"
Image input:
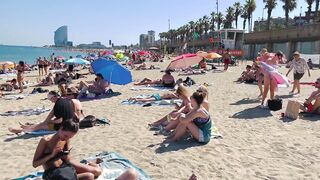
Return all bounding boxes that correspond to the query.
[159,86,209,135]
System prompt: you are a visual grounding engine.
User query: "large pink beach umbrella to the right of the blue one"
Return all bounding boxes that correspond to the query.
[167,54,203,70]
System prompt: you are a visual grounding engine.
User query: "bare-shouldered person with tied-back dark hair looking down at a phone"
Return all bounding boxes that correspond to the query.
[32,118,137,180]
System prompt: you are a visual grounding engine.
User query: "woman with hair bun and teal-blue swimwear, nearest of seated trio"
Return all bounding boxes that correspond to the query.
[168,91,212,143]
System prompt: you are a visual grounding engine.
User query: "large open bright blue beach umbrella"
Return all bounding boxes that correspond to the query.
[91,58,132,85]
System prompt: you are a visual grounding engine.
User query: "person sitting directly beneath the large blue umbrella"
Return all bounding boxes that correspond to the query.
[79,73,110,95]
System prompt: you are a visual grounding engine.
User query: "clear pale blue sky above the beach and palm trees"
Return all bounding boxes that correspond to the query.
[0,0,314,46]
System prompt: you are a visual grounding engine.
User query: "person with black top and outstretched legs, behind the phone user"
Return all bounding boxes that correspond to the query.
[8,91,84,134]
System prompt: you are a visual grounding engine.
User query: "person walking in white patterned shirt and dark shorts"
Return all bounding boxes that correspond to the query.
[286,51,311,94]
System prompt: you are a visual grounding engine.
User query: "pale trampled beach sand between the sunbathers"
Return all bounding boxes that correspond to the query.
[0,60,320,180]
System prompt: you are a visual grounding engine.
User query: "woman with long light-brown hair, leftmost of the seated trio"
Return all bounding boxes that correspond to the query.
[149,84,191,128]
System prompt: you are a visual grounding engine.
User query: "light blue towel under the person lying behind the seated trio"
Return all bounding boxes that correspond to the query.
[121,95,182,106]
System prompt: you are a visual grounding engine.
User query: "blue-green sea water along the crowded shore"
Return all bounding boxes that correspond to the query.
[0,45,86,64]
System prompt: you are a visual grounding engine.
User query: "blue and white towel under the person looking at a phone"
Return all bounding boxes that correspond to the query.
[14,152,150,180]
